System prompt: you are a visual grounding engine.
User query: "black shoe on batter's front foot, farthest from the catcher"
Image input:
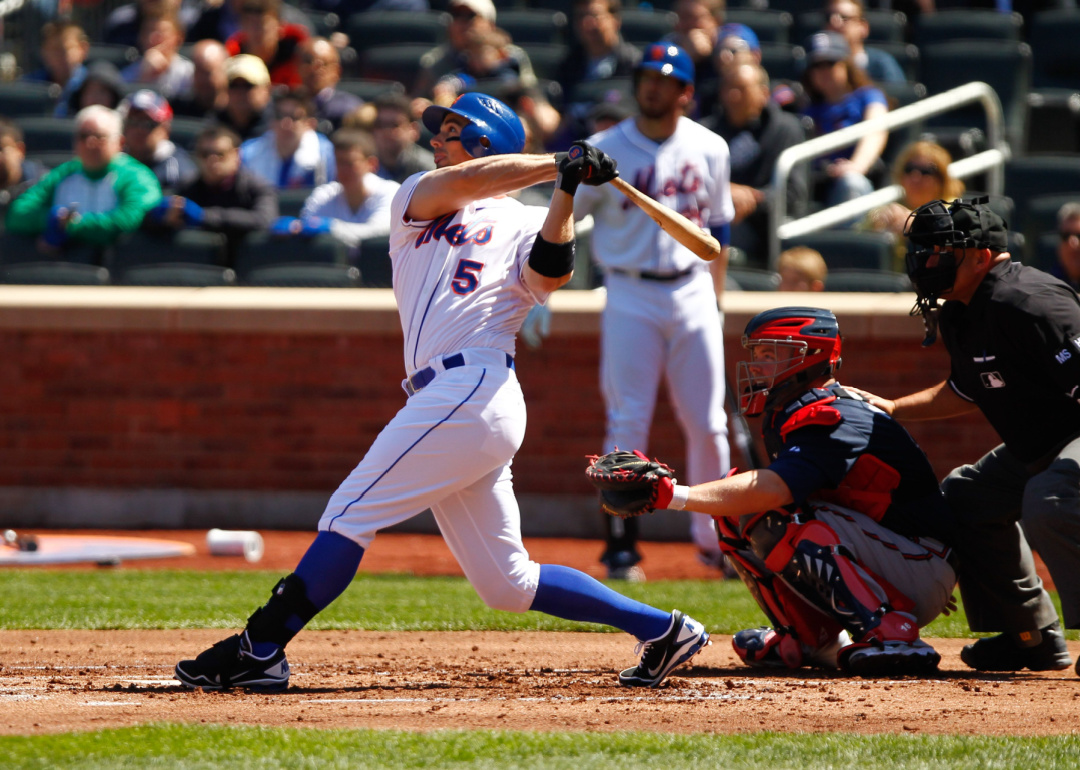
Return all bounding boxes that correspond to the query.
[176,631,288,692]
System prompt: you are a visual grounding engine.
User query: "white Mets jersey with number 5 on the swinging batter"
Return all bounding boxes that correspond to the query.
[390,174,548,373]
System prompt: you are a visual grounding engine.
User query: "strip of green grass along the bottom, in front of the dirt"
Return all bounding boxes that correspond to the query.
[0,725,1080,770]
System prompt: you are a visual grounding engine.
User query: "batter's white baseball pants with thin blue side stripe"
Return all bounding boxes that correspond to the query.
[319,349,540,612]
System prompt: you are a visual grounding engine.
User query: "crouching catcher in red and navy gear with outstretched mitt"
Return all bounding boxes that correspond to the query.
[586,308,956,676]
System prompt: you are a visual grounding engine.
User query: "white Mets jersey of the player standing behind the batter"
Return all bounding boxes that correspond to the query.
[573,118,734,273]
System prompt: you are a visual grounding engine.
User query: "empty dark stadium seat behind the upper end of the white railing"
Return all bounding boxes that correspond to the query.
[919,40,1031,150]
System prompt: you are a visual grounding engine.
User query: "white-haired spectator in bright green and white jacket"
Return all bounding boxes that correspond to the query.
[8,105,161,258]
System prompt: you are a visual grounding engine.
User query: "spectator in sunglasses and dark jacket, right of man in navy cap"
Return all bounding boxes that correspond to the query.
[150,125,278,261]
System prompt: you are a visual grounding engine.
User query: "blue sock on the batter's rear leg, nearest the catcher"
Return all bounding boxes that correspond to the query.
[529,564,672,640]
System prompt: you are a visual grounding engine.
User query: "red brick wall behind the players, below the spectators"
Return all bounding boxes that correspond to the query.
[0,293,997,496]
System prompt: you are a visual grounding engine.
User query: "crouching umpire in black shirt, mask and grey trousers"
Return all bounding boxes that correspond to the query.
[864,198,1080,673]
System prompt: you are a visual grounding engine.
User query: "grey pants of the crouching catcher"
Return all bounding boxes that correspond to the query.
[813,503,956,629]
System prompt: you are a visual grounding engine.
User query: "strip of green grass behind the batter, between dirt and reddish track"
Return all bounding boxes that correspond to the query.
[0,569,1077,638]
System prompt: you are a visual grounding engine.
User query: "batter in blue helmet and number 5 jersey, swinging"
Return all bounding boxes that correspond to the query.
[176,93,708,690]
